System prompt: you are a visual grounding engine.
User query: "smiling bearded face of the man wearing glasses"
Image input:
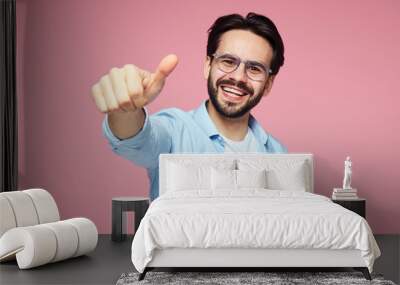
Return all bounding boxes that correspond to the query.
[204,30,274,118]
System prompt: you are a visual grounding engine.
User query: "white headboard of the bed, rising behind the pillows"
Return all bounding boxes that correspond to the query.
[159,153,314,195]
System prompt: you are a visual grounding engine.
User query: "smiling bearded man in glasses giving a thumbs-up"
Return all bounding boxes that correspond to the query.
[92,13,287,200]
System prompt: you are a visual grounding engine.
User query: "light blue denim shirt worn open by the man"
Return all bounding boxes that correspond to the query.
[103,100,287,200]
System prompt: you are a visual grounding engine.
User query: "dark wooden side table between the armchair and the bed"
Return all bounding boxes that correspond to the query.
[111,197,149,241]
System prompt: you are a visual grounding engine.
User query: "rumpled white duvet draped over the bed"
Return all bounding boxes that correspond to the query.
[132,189,380,272]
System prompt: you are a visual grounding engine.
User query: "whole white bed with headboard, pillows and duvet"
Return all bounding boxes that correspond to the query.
[132,153,380,279]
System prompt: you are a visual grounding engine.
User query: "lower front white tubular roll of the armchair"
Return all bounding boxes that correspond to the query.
[0,218,98,269]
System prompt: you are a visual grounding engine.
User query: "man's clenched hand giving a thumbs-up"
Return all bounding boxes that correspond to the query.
[92,54,178,113]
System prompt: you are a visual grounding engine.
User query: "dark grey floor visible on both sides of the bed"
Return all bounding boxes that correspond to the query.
[0,235,400,285]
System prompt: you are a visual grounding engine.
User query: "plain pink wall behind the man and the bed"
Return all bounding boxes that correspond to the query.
[17,0,400,233]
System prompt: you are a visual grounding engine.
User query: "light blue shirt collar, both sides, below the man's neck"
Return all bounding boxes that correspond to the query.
[194,100,268,145]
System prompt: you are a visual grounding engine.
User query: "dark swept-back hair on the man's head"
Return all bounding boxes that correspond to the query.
[207,12,284,74]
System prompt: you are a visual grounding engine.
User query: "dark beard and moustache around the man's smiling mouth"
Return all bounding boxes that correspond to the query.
[207,75,265,118]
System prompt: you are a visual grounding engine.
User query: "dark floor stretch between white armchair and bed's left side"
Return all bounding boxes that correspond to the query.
[0,235,134,285]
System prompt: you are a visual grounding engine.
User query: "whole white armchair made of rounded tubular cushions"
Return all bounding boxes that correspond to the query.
[0,189,98,269]
